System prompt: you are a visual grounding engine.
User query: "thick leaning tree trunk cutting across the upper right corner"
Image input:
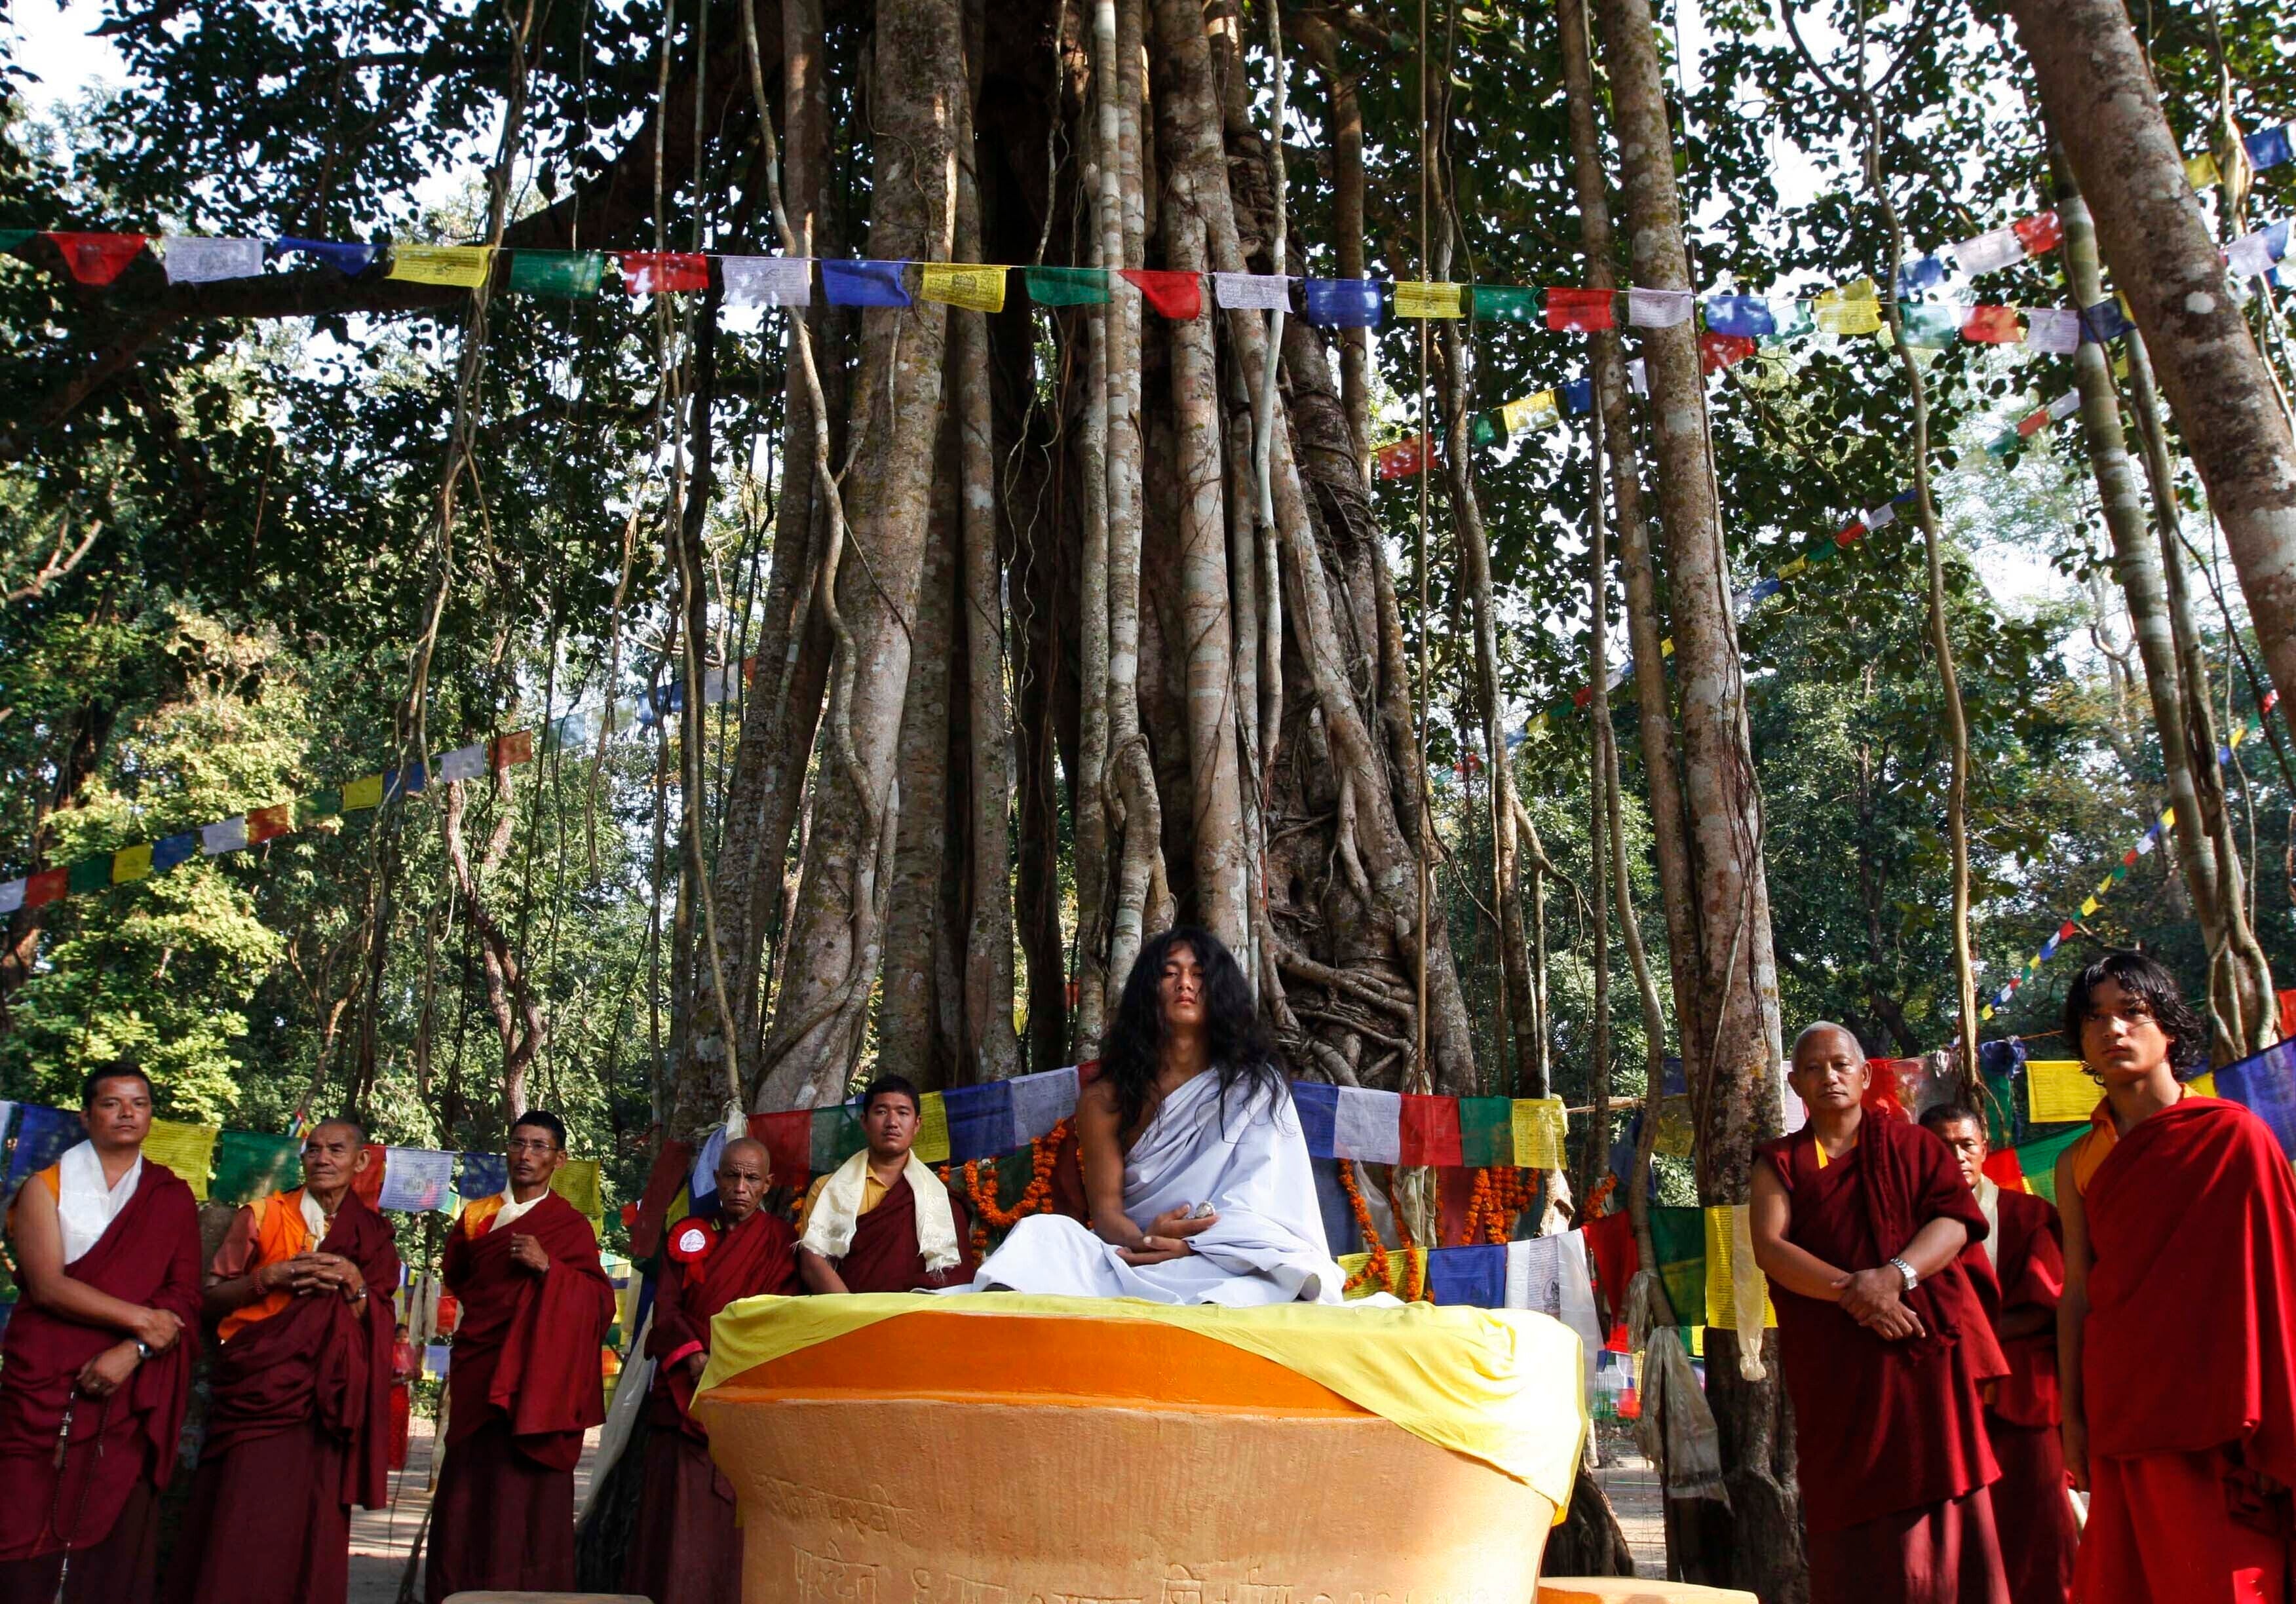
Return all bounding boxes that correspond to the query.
[2009,0,2296,716]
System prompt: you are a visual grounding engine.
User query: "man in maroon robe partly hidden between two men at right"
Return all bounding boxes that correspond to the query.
[1922,1104,2080,1604]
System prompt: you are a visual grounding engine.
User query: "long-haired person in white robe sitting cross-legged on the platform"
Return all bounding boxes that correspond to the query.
[950,927,1343,1306]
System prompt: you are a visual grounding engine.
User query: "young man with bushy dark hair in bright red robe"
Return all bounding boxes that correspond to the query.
[2057,952,2296,1604]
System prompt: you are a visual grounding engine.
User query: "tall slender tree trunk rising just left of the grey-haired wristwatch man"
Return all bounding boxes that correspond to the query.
[1596,0,1809,1604]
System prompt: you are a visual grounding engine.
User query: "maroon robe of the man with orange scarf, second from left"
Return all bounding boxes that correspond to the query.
[168,1193,400,1604]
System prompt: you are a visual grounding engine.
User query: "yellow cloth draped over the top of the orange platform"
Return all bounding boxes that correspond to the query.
[700,1292,1586,1523]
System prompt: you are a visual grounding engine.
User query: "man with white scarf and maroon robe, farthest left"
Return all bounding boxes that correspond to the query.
[0,1062,200,1604]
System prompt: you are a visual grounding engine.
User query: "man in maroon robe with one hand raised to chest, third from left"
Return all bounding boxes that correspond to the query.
[425,1111,613,1599]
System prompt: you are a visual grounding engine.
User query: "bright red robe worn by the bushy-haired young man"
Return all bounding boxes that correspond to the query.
[2073,1097,2296,1604]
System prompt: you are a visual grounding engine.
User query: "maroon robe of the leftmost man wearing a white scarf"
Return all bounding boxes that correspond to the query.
[0,1159,200,1604]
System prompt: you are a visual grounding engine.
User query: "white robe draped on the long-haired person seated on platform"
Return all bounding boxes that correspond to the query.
[951,1069,1345,1308]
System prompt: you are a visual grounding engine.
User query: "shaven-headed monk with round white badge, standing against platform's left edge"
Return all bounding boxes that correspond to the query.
[622,1136,803,1604]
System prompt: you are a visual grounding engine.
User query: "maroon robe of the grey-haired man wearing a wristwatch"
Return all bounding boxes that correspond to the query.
[1763,1111,2009,1604]
